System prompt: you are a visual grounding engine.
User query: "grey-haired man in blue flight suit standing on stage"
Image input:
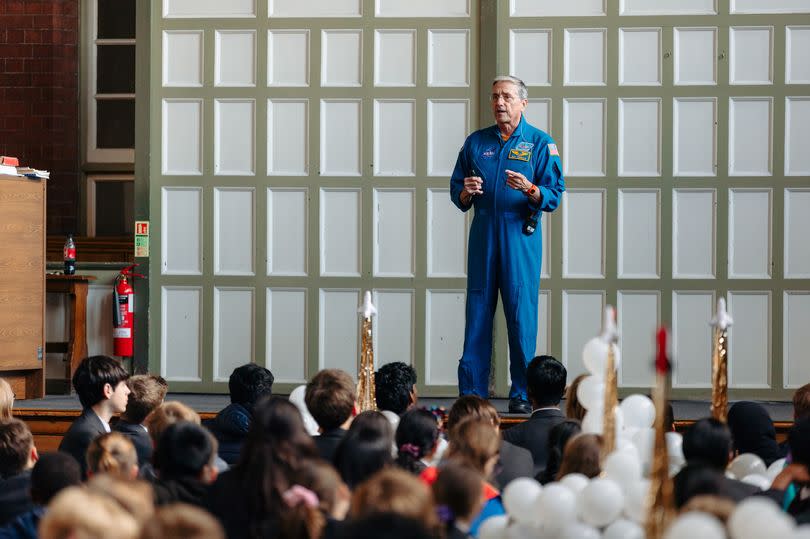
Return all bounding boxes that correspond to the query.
[450,76,565,414]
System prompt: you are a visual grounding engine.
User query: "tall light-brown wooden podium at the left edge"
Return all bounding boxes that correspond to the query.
[0,175,45,399]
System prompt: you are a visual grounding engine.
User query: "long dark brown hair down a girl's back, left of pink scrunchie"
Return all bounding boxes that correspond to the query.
[232,397,318,537]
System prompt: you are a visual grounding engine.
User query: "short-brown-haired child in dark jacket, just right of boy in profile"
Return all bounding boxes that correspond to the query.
[113,374,169,467]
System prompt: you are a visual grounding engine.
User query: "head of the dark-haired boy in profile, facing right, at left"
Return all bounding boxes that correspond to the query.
[73,356,129,412]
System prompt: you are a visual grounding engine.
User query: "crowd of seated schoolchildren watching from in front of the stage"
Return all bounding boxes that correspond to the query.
[12,356,810,539]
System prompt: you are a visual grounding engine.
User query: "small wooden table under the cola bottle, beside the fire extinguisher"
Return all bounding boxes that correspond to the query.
[45,273,96,387]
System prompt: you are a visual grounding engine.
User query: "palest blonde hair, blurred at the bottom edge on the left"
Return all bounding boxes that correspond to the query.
[39,487,140,539]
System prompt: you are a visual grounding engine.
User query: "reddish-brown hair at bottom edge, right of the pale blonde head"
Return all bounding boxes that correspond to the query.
[140,503,225,539]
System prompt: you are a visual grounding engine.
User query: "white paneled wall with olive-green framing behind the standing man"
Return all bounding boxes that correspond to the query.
[152,0,810,394]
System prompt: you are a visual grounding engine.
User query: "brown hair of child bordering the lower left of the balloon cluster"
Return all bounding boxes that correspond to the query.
[433,461,484,529]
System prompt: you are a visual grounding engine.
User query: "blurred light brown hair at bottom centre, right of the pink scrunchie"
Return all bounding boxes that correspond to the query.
[350,468,438,530]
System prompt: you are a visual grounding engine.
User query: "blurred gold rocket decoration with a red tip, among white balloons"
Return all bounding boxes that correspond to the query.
[645,327,675,539]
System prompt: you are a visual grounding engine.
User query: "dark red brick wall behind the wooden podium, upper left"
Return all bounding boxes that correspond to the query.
[0,0,79,235]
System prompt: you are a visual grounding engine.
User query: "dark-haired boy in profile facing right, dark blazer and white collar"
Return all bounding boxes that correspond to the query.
[59,356,129,477]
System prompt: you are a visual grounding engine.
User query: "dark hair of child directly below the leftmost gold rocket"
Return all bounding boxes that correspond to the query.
[335,412,394,489]
